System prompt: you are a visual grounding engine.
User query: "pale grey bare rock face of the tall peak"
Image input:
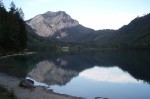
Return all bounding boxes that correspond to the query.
[26,11,79,38]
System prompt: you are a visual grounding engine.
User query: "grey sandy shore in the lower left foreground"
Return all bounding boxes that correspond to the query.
[0,73,84,99]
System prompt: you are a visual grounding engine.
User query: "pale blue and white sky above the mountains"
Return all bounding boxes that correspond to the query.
[3,0,150,30]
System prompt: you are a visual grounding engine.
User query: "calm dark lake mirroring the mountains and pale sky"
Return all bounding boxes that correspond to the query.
[0,51,150,99]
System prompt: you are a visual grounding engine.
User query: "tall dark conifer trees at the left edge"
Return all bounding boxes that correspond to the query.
[0,2,27,52]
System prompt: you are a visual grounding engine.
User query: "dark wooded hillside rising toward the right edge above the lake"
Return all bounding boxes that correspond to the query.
[95,14,150,49]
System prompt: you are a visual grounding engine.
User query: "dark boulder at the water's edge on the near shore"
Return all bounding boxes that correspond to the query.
[19,79,35,89]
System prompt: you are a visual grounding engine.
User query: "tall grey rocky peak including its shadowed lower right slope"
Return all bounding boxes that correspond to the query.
[26,11,94,42]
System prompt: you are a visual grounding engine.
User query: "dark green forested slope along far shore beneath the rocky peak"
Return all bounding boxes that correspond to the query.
[26,25,93,53]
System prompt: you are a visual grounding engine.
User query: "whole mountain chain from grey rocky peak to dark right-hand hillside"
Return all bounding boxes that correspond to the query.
[26,11,150,49]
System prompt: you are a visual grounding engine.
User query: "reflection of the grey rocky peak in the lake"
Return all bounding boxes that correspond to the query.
[28,61,78,85]
